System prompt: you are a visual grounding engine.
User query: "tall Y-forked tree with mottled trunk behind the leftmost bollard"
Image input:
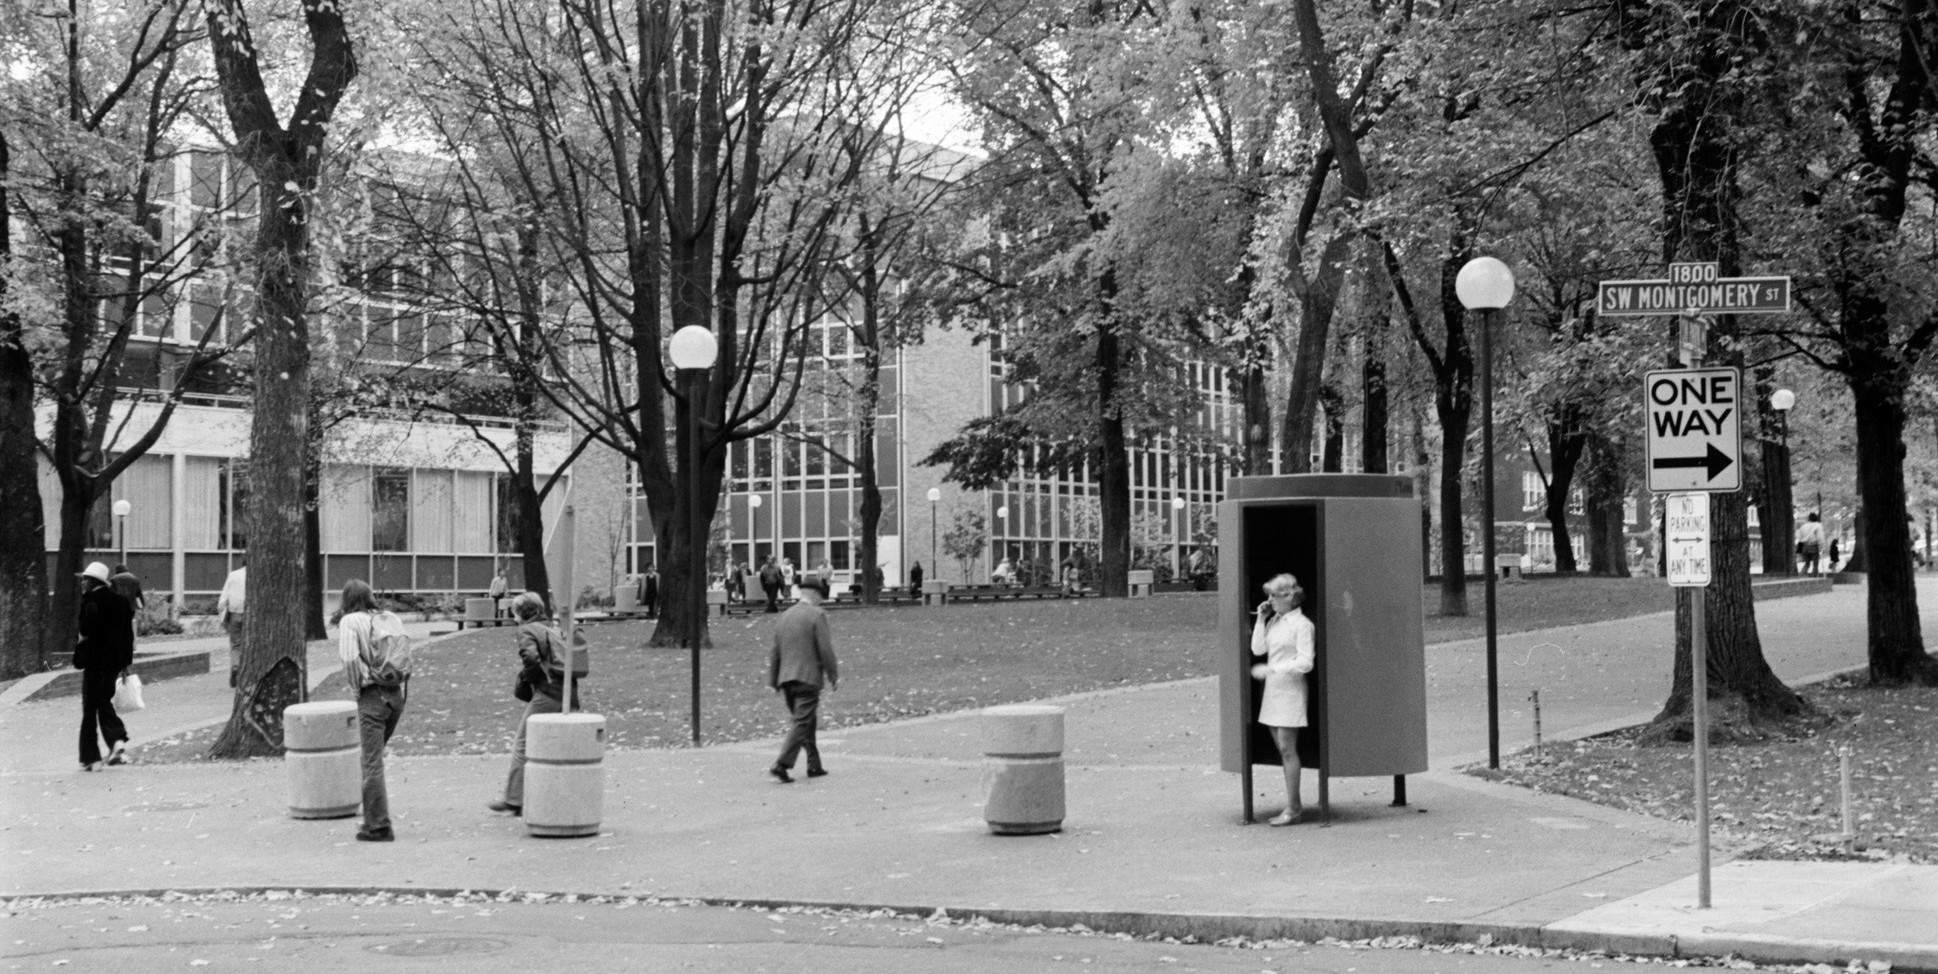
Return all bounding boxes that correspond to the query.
[203,0,357,757]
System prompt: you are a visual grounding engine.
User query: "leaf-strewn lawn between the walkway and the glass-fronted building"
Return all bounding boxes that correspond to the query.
[136,577,1669,763]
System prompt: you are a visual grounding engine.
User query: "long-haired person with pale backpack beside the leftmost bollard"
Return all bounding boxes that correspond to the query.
[337,579,411,842]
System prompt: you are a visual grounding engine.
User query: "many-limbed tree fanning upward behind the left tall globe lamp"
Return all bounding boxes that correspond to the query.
[405,0,914,645]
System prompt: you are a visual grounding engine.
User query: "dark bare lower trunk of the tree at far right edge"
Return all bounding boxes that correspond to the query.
[1851,368,1938,685]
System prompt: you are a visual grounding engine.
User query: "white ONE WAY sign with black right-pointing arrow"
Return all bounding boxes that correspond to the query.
[1643,368,1742,492]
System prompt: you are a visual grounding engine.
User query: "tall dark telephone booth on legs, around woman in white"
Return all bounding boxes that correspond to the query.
[1219,474,1426,823]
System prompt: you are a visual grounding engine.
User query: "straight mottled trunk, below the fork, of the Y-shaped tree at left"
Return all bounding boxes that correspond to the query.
[209,161,310,757]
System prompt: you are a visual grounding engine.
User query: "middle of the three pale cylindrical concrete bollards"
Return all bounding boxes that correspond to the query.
[523,713,605,837]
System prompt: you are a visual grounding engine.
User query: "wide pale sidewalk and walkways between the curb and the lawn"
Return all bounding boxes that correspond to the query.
[0,579,1938,970]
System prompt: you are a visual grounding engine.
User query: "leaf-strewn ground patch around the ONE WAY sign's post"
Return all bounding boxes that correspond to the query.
[1471,678,1938,864]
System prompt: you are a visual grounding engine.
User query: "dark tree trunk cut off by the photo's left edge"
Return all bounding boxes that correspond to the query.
[0,132,47,680]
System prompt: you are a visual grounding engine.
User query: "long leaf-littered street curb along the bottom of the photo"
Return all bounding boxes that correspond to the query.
[0,883,1938,974]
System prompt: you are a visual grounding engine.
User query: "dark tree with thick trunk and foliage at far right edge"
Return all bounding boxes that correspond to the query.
[1779,0,1938,685]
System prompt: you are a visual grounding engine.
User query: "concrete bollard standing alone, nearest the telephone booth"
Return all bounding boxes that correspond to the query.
[983,703,1064,835]
